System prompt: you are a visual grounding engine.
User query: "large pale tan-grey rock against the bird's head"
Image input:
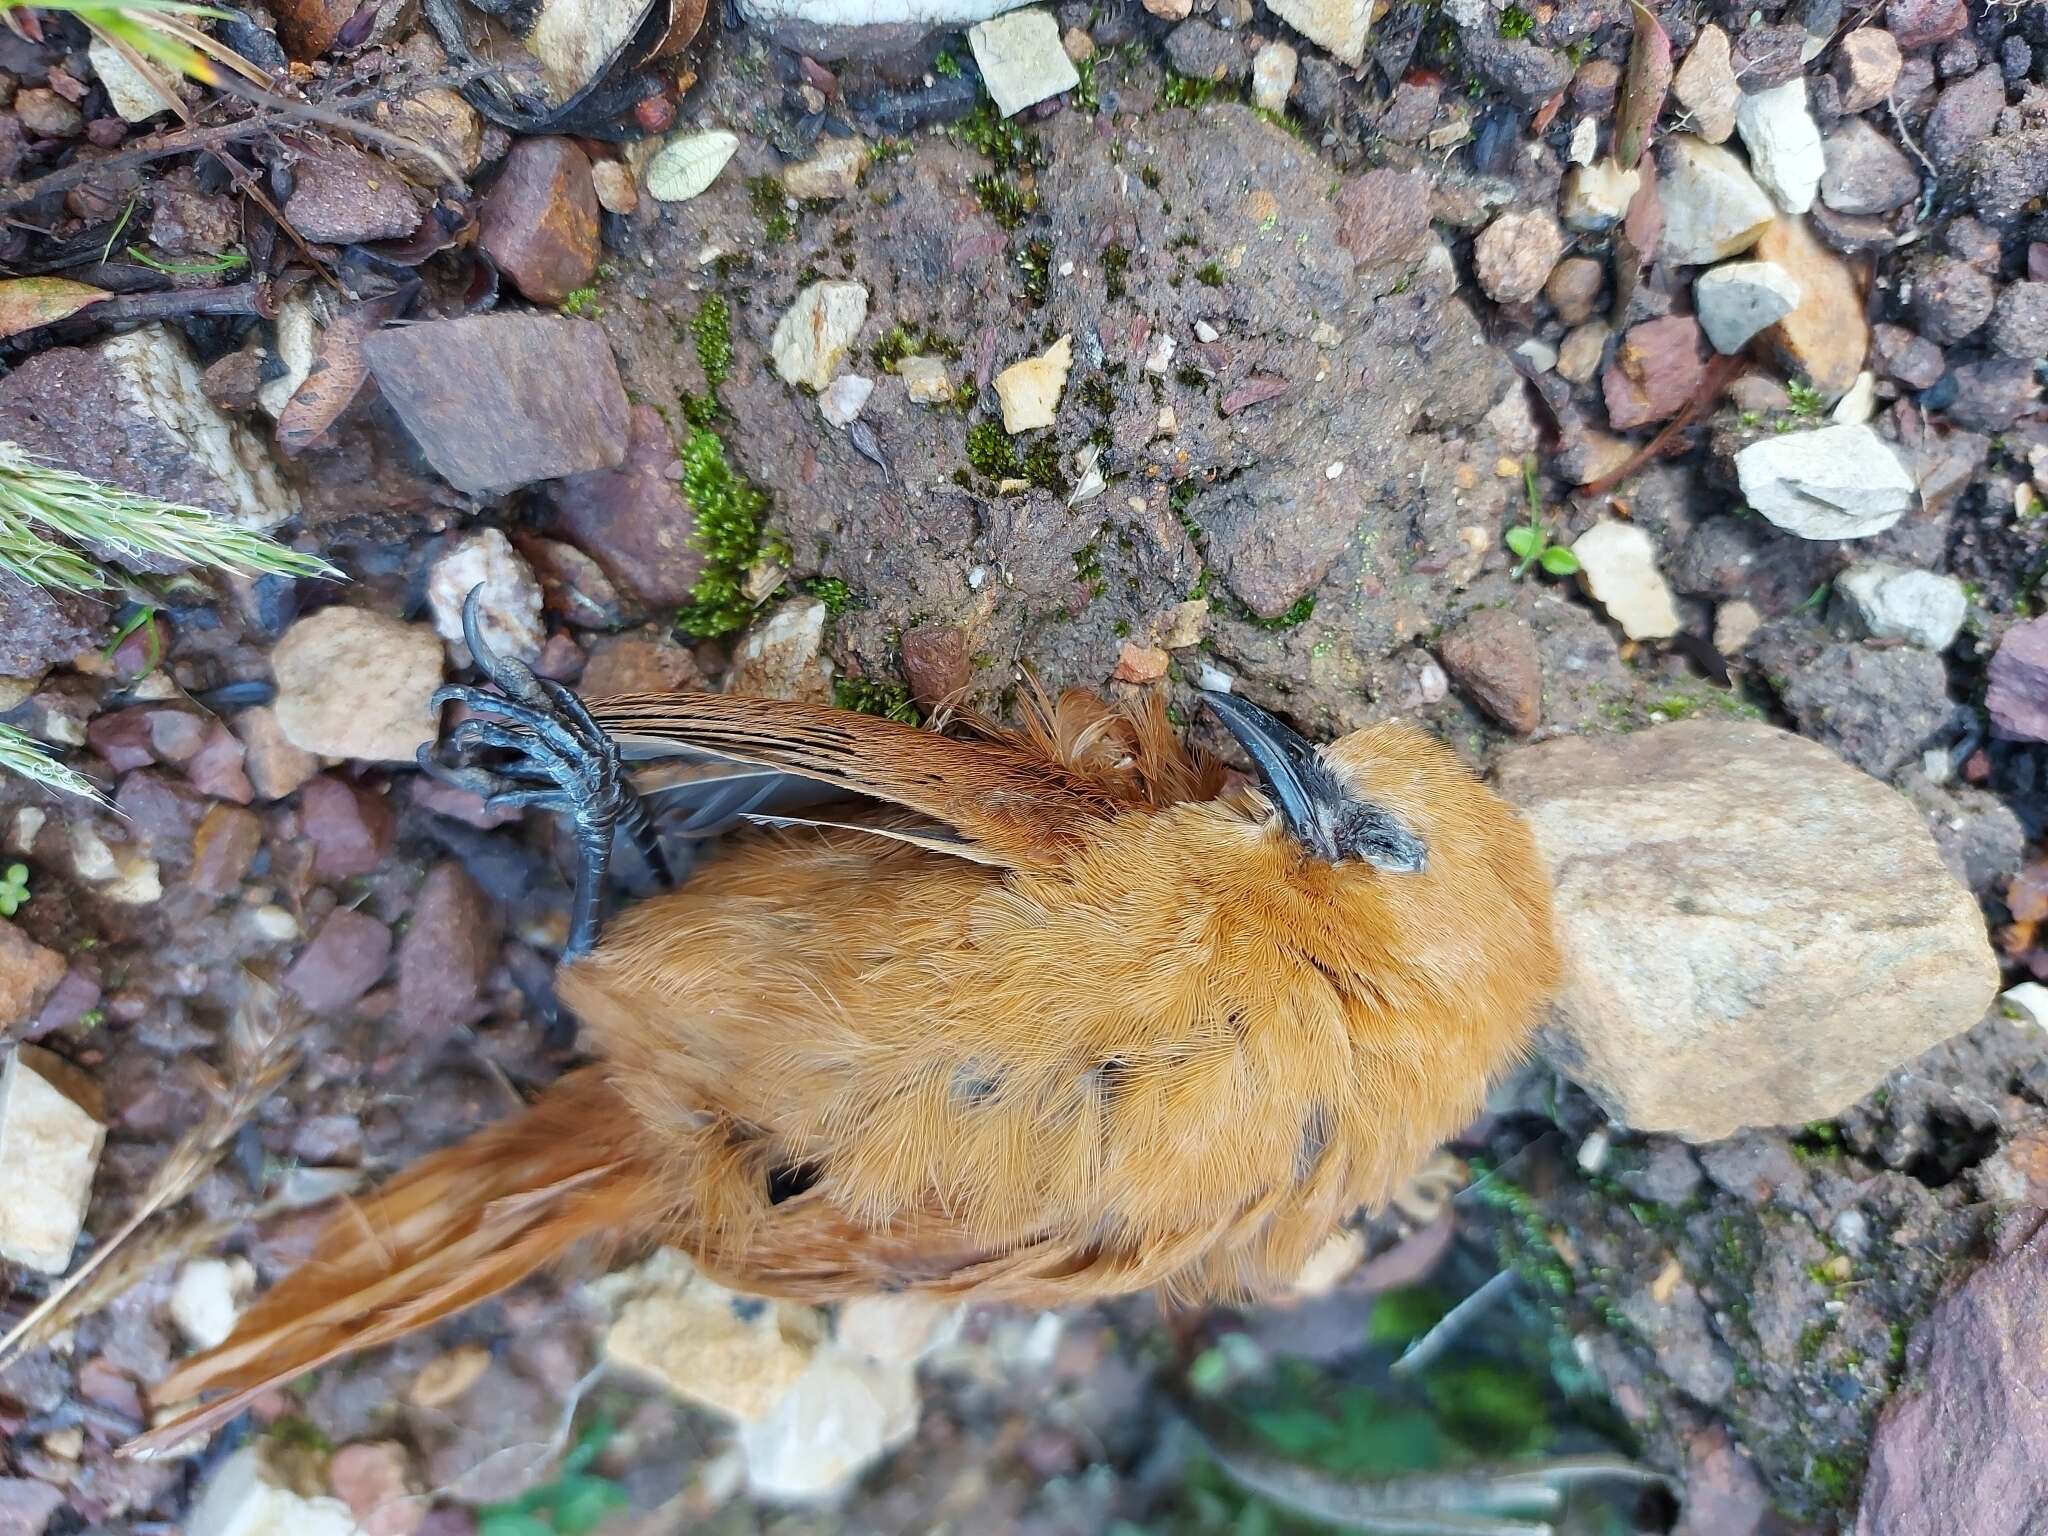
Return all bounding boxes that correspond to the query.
[1499,721,1999,1141]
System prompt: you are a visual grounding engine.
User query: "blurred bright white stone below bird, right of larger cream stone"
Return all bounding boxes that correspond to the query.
[739,1346,920,1503]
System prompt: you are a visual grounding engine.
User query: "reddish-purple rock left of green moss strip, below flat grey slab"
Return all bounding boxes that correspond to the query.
[555,406,705,606]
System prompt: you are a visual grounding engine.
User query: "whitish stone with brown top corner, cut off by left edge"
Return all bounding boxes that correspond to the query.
[0,1044,106,1274]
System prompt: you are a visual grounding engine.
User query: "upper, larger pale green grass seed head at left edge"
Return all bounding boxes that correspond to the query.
[0,442,340,592]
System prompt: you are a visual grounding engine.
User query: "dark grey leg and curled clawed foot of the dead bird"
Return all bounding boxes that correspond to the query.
[420,588,674,958]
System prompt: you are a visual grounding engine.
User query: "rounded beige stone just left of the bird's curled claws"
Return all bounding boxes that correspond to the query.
[270,606,444,764]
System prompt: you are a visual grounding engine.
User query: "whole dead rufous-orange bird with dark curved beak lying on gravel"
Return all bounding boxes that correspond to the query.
[143,598,1559,1450]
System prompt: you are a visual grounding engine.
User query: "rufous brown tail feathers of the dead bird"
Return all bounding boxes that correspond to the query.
[123,1069,664,1456]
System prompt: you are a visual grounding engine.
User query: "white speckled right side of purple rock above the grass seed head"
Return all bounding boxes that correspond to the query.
[98,326,299,530]
